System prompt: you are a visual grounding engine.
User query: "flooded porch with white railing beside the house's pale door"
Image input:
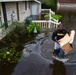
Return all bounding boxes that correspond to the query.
[30,9,61,30]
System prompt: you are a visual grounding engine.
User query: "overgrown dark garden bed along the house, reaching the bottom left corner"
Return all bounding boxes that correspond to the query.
[0,23,35,75]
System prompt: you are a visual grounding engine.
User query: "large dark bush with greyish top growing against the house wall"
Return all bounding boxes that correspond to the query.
[0,21,34,51]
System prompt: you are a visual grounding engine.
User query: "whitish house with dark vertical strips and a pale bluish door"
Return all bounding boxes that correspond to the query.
[0,0,41,26]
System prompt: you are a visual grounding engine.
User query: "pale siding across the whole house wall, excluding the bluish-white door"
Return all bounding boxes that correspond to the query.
[0,1,41,23]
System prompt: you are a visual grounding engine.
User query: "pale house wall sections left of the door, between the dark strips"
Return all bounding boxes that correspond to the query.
[5,2,31,21]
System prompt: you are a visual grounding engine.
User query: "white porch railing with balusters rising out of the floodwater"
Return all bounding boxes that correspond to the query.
[32,9,61,29]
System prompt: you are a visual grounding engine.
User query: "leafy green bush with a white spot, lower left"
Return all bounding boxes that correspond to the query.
[0,47,21,66]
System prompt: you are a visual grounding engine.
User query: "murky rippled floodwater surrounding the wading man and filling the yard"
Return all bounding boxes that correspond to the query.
[0,8,76,75]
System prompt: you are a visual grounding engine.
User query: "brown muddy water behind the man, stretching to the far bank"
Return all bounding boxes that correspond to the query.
[57,9,76,31]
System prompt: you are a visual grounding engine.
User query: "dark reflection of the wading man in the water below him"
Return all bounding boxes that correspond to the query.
[50,60,66,75]
